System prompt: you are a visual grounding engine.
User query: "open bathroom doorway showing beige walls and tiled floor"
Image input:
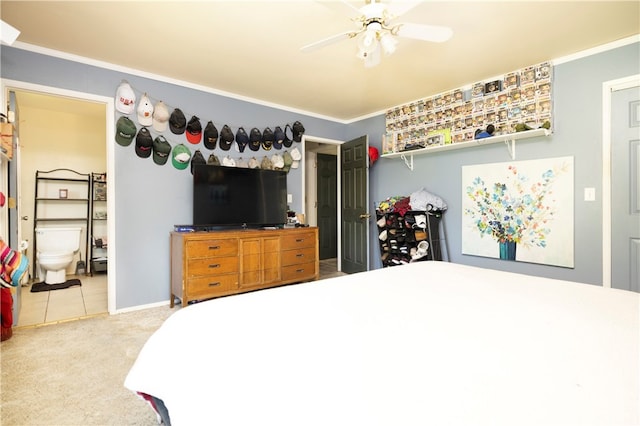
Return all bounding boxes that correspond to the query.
[3,81,115,327]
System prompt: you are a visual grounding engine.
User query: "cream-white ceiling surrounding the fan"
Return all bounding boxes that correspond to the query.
[0,0,640,122]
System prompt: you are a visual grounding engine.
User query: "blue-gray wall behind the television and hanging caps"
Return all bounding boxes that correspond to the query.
[1,46,346,310]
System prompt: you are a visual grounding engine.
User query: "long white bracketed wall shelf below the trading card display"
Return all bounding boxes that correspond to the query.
[381,129,551,170]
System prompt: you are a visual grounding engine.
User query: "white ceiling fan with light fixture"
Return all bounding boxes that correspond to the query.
[300,0,453,67]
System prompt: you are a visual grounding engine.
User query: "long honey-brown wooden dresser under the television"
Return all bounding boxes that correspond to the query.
[170,228,320,308]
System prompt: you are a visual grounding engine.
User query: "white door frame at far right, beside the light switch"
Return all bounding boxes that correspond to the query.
[602,74,640,288]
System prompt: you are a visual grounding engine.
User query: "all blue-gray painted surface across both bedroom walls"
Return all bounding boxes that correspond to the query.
[1,43,640,309]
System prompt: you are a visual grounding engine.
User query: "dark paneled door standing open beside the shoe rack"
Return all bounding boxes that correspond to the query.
[340,136,369,274]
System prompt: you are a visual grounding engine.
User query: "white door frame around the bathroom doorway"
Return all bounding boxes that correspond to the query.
[0,79,117,314]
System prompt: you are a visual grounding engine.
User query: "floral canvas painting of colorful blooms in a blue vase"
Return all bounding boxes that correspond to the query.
[462,157,574,268]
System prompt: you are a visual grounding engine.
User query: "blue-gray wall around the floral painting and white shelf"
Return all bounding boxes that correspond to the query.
[347,43,640,284]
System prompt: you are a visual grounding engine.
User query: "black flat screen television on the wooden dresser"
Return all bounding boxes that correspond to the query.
[193,164,287,229]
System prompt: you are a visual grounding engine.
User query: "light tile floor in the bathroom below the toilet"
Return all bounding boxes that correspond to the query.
[15,274,107,327]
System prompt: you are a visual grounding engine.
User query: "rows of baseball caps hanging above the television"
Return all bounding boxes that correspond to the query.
[115,80,305,172]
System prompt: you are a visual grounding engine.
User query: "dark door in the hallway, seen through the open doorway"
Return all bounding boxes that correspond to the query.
[316,154,338,260]
